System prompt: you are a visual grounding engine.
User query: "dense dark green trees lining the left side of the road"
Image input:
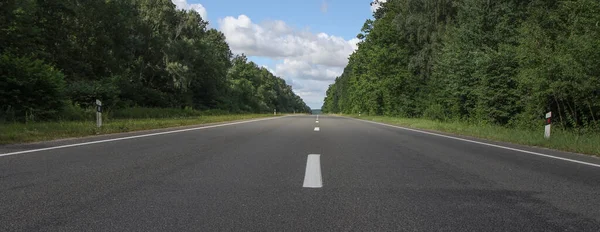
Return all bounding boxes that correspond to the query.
[0,0,310,120]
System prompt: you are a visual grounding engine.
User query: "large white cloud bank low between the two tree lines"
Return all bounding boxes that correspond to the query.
[218,15,359,108]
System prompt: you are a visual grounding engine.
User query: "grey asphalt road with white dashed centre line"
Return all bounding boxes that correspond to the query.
[0,115,600,231]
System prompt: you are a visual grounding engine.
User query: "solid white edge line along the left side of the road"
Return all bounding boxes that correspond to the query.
[0,116,288,157]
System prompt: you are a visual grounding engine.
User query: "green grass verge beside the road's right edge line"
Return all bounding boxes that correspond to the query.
[345,115,600,156]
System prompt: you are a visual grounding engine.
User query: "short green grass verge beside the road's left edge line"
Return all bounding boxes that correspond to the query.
[0,114,273,144]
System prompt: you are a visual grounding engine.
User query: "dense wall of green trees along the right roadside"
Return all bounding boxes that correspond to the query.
[323,0,600,128]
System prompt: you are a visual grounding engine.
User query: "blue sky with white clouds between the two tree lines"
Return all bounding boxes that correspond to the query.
[171,0,386,109]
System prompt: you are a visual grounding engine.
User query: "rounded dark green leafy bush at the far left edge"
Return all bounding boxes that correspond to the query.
[0,54,65,121]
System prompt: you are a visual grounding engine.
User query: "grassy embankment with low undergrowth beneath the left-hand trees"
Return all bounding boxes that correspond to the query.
[0,108,282,144]
